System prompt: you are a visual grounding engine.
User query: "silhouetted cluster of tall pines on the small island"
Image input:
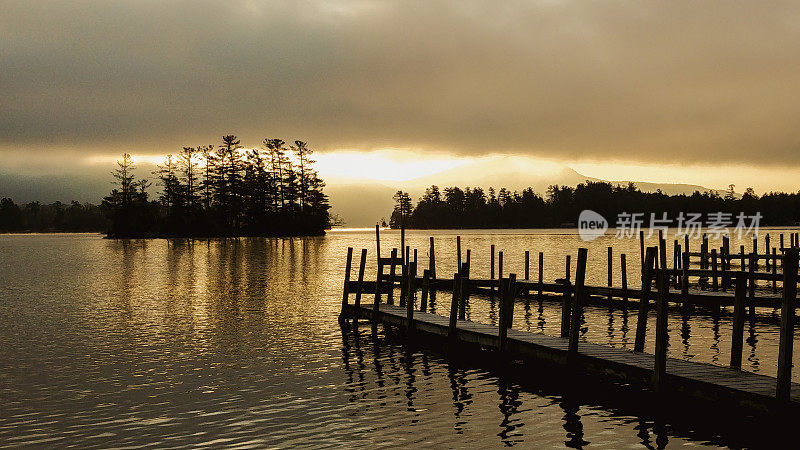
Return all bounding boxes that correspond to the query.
[101,135,331,237]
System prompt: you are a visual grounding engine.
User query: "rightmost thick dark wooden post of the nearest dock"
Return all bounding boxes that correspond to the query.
[775,248,797,402]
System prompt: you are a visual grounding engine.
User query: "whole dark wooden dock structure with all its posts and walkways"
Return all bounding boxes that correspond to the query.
[340,229,800,417]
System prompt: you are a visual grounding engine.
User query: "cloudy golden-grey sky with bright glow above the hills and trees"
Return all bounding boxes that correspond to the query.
[0,0,800,204]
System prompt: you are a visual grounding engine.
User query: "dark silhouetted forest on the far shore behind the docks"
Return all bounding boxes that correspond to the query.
[389,181,800,229]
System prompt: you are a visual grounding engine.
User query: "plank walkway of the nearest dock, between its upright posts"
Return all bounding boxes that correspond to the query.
[343,304,800,413]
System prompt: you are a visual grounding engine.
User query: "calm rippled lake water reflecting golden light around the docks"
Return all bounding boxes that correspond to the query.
[0,230,800,448]
